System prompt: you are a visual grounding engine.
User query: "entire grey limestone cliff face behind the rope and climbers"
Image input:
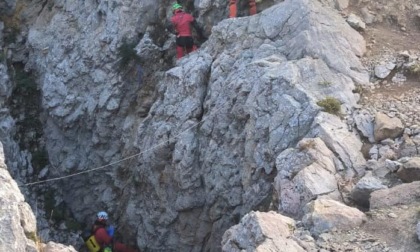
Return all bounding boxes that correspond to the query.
[0,0,418,251]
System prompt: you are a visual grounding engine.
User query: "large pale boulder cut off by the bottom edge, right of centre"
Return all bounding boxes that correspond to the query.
[222,211,305,252]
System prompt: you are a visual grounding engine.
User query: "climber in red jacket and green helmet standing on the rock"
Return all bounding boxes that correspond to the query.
[170,3,205,59]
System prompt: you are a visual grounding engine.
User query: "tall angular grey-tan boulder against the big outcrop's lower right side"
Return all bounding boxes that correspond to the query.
[275,138,339,215]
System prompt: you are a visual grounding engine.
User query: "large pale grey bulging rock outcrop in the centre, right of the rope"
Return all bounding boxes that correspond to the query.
[123,1,367,250]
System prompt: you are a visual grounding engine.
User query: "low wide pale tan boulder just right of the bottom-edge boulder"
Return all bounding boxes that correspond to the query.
[302,199,366,235]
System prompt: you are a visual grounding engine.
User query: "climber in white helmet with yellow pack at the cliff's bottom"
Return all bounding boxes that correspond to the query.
[92,211,139,252]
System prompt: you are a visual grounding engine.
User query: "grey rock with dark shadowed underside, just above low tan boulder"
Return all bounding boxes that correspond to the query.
[351,175,387,208]
